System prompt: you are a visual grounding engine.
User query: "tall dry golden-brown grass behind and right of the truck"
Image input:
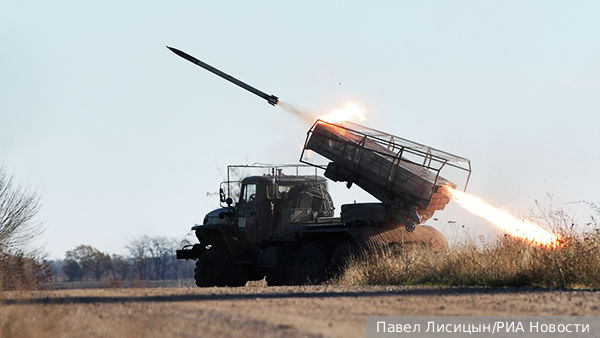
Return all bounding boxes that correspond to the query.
[336,227,600,288]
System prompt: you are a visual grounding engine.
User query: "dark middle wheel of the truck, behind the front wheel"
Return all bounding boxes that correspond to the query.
[294,243,331,285]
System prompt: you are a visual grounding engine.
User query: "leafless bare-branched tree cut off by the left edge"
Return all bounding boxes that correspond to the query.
[0,167,43,251]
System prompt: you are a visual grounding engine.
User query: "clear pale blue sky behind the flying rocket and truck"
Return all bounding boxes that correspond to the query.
[0,1,600,258]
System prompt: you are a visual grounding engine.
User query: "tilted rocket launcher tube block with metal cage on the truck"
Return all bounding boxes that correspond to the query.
[300,120,471,218]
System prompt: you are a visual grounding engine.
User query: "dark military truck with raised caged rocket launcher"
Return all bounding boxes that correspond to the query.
[177,120,471,287]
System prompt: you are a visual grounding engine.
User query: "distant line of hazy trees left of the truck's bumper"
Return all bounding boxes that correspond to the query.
[54,236,194,282]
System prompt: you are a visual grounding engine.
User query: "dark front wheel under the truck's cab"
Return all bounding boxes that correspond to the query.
[194,246,248,287]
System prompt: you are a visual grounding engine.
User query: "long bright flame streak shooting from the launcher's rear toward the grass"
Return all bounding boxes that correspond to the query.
[445,186,562,249]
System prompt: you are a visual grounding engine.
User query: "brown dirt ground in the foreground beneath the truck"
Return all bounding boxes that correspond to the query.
[0,283,600,338]
